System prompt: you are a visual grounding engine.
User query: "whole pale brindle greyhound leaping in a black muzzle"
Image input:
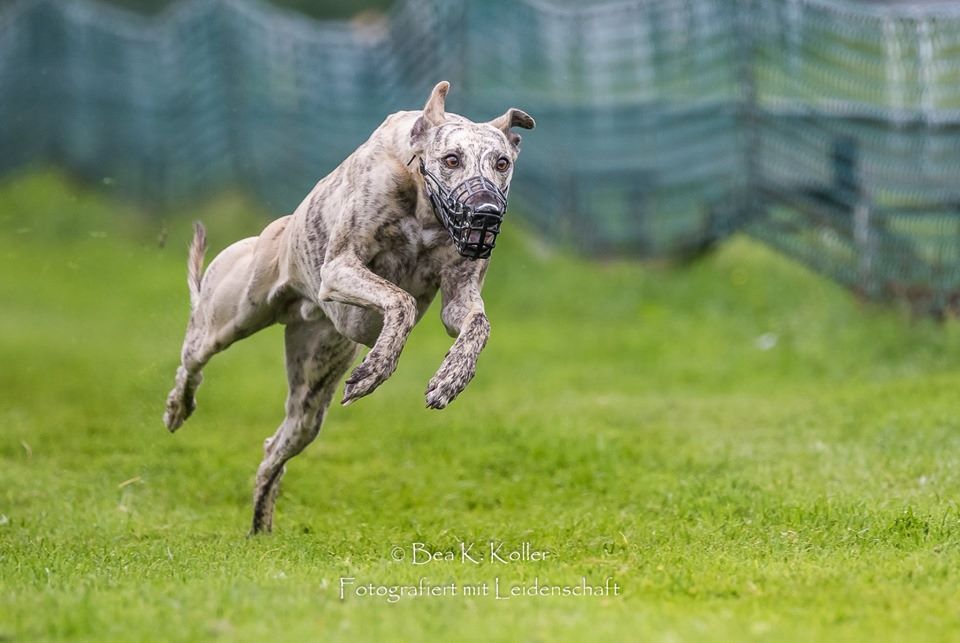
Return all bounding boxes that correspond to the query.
[163,81,535,534]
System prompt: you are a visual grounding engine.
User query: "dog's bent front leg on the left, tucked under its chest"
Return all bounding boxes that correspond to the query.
[317,251,417,405]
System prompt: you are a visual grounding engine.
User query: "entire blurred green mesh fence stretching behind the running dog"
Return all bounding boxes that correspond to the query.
[0,0,960,313]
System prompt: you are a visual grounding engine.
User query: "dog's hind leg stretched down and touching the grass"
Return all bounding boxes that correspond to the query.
[251,318,358,534]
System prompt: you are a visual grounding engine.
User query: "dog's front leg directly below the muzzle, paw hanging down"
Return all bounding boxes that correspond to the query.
[426,261,490,409]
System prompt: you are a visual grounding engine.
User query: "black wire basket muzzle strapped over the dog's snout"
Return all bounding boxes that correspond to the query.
[420,159,507,259]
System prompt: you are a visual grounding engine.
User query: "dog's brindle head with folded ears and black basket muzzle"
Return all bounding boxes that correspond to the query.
[410,81,535,259]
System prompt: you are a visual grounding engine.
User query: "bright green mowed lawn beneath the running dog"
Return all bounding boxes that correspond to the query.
[0,175,960,641]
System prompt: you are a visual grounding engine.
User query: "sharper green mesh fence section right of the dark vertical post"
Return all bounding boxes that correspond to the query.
[750,0,960,314]
